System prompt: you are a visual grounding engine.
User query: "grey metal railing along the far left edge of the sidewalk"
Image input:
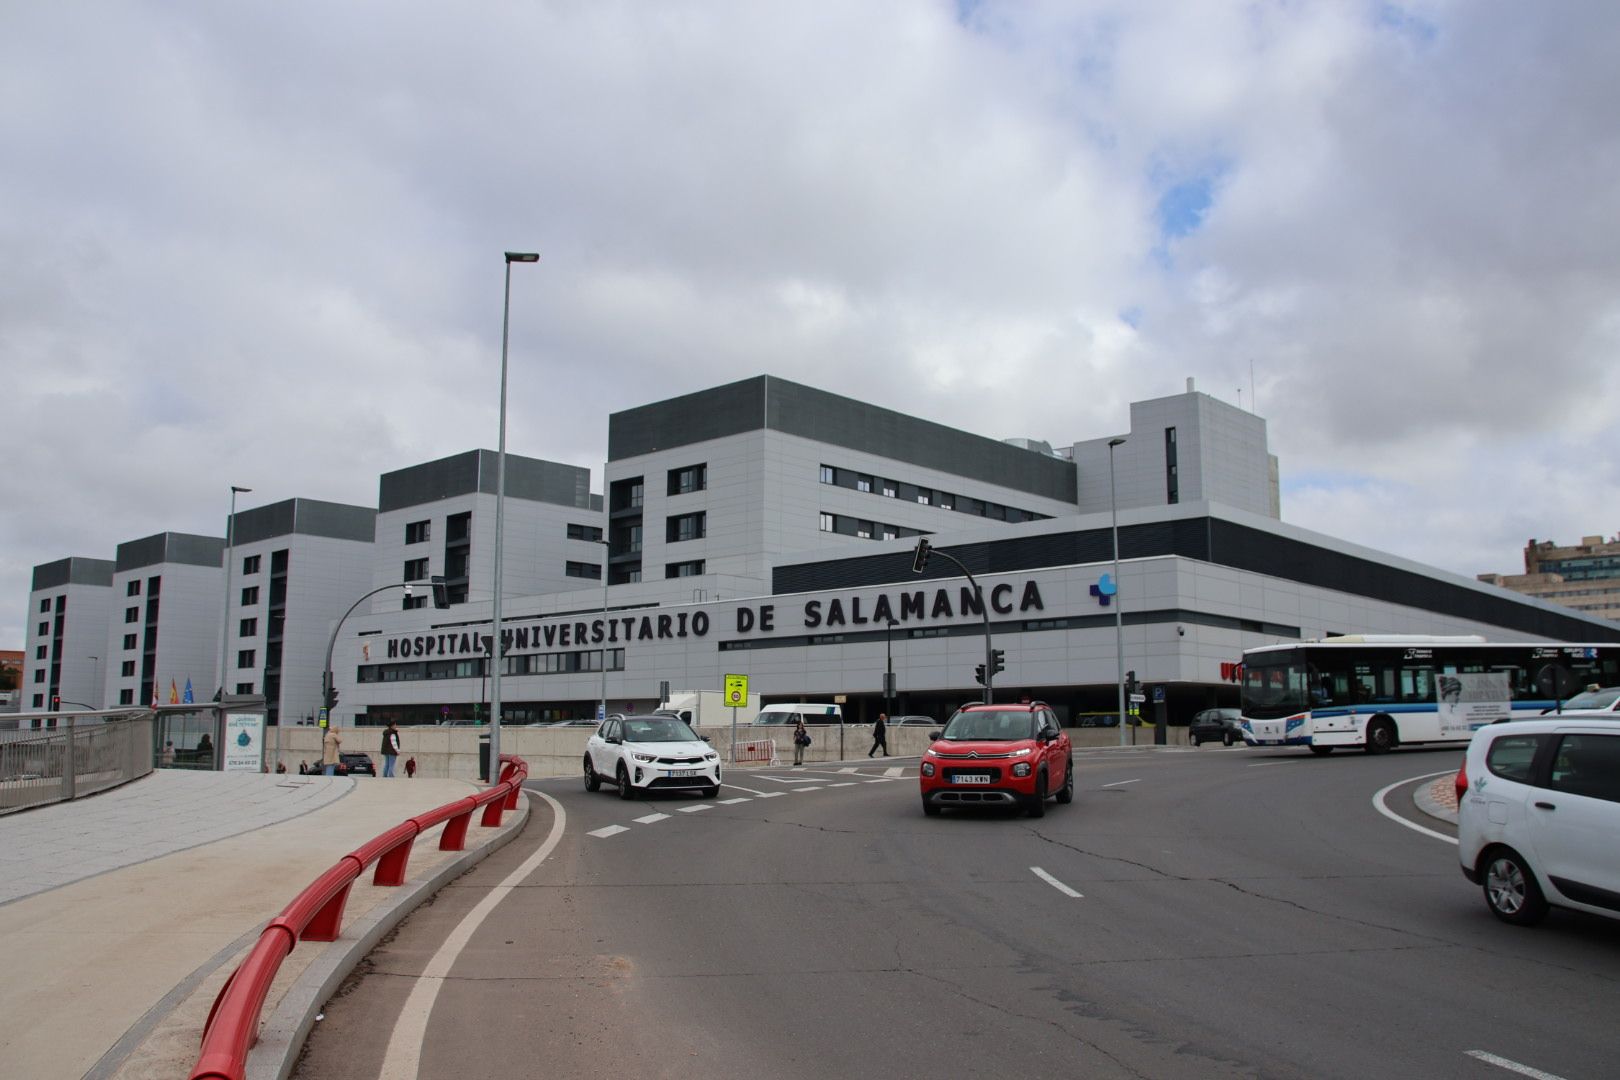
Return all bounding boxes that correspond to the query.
[0,714,152,814]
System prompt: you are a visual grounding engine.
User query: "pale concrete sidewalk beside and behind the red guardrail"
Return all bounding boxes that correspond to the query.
[0,771,523,1080]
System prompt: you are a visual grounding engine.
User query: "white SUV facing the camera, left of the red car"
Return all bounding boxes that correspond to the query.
[585,716,719,798]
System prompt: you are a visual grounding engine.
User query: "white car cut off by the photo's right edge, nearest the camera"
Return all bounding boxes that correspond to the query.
[1456,717,1620,926]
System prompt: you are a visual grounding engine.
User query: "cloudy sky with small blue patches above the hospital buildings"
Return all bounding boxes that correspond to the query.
[0,0,1620,648]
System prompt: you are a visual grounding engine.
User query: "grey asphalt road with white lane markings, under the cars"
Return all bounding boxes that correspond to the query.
[296,746,1620,1080]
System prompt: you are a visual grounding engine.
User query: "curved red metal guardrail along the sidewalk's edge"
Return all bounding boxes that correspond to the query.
[191,755,528,1080]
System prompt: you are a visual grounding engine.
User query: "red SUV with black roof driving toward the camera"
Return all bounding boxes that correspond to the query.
[919,701,1074,818]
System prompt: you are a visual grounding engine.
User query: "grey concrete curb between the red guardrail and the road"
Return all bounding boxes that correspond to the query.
[246,797,530,1080]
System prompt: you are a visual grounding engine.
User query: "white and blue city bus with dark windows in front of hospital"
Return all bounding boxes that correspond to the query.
[1241,635,1620,755]
